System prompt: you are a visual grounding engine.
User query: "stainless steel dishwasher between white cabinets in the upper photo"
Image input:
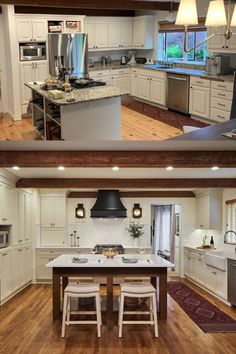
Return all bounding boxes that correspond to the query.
[167,73,190,114]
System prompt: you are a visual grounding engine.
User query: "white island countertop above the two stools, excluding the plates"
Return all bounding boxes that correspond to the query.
[46,254,174,268]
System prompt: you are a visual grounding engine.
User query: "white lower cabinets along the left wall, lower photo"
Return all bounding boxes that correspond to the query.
[0,245,33,303]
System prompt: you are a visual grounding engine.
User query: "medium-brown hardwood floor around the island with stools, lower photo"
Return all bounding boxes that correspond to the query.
[0,277,236,354]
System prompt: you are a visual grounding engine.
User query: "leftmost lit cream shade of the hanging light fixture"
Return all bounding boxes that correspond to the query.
[175,0,198,26]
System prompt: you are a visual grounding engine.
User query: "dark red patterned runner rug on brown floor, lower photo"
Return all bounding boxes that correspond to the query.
[168,281,236,333]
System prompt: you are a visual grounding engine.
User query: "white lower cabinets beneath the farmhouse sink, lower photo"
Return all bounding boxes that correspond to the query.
[184,251,227,299]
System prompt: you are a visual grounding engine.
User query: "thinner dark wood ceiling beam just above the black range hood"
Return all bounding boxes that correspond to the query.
[16,178,236,189]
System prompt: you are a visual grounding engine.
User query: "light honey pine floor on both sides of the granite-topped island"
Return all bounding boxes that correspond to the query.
[0,107,182,140]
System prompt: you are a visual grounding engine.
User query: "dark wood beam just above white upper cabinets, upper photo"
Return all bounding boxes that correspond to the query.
[15,6,135,17]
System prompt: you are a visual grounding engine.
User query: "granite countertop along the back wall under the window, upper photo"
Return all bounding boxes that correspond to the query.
[89,63,234,82]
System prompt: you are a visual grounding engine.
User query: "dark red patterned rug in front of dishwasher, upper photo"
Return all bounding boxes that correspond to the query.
[122,96,208,130]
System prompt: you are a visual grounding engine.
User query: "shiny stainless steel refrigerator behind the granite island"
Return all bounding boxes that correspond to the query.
[48,33,88,78]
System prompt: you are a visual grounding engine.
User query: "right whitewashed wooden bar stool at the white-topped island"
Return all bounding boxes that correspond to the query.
[118,282,158,338]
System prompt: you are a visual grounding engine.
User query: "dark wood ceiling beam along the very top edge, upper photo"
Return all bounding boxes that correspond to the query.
[1,0,179,11]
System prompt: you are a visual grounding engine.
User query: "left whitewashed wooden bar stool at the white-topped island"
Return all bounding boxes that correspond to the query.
[61,282,102,337]
